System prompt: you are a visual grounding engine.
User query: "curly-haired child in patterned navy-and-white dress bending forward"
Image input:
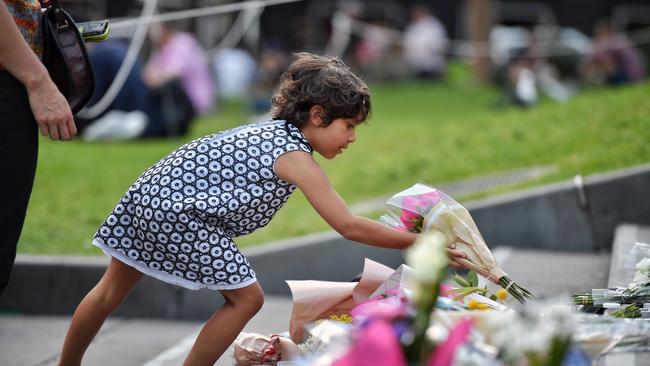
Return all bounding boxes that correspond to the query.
[59,53,464,365]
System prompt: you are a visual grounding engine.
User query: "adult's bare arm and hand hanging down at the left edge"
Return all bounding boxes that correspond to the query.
[0,1,77,140]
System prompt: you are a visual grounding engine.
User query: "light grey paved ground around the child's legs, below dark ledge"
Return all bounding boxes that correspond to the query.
[0,297,291,366]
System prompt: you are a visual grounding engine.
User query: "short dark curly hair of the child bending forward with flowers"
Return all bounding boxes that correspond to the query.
[271,52,370,128]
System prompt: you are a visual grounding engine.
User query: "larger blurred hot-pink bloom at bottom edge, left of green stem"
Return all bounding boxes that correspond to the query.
[332,320,406,366]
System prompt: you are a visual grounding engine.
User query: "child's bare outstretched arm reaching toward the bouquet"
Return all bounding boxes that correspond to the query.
[275,151,467,267]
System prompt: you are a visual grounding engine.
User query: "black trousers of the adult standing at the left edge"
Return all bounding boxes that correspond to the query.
[0,70,38,296]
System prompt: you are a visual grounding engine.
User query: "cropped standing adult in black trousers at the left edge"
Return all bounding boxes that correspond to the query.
[0,0,77,296]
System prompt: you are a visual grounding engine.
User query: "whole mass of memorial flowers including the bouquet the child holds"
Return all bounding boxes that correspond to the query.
[228,185,650,366]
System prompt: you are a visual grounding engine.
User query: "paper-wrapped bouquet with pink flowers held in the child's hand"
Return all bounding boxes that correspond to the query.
[381,183,534,303]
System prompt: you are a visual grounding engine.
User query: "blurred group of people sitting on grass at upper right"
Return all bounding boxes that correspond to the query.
[490,20,646,107]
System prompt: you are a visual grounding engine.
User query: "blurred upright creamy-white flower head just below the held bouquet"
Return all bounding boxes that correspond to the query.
[406,231,447,284]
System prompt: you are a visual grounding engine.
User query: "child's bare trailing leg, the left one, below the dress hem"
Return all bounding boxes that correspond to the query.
[59,258,142,366]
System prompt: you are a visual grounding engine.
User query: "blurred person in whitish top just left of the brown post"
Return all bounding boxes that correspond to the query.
[404,5,448,80]
